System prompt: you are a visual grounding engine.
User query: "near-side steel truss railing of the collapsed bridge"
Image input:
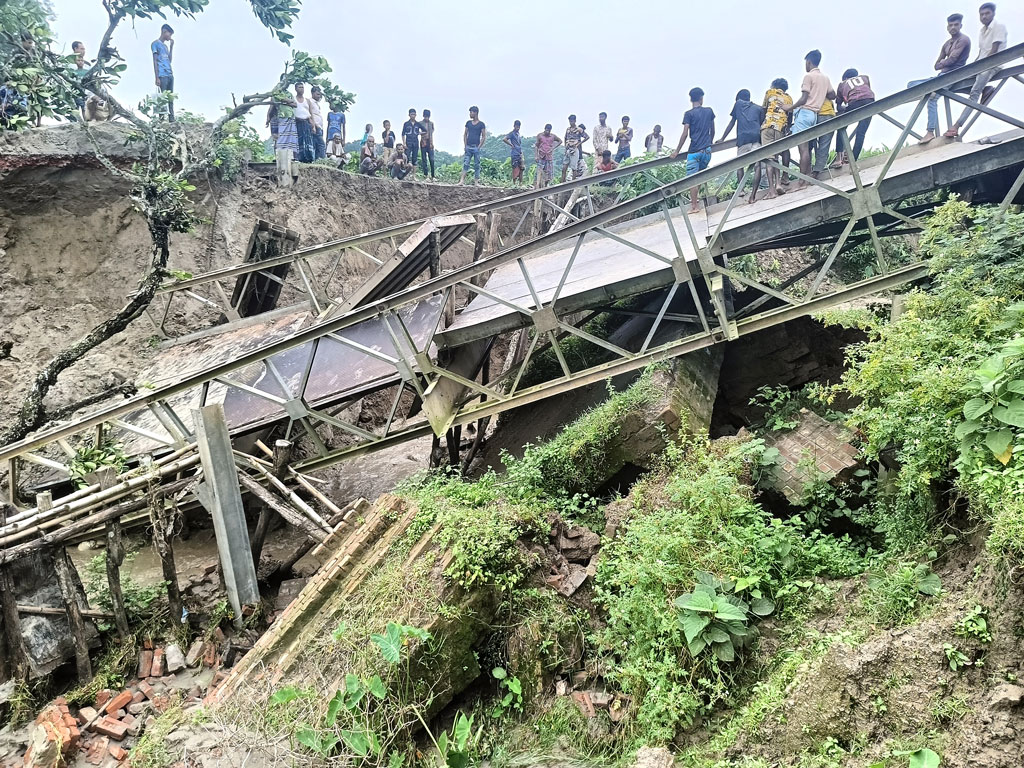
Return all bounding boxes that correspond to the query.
[0,45,1024,524]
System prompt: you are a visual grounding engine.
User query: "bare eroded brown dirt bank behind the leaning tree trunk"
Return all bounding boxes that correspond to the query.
[0,126,505,434]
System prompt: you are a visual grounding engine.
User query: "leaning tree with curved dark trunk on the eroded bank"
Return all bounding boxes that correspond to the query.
[0,0,354,444]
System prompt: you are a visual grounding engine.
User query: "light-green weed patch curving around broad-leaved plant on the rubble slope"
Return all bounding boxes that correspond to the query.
[595,442,863,743]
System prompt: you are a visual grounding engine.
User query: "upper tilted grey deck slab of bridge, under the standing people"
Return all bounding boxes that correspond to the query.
[437,130,1024,346]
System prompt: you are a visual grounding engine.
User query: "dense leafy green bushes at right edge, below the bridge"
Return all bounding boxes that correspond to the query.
[840,200,1024,559]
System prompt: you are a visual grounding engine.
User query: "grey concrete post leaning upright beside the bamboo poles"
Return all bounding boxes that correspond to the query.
[193,403,259,627]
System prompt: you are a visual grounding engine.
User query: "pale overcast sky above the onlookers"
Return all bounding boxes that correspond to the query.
[53,0,1024,153]
